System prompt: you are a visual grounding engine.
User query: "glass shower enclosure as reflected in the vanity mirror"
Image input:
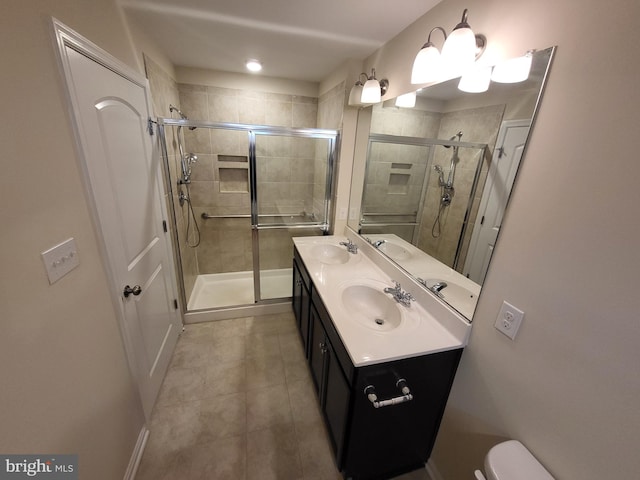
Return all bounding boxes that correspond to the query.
[359,132,487,270]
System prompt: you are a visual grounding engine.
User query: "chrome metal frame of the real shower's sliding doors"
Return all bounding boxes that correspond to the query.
[157,118,340,313]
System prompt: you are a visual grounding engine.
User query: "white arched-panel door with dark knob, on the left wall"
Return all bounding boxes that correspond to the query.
[55,24,182,418]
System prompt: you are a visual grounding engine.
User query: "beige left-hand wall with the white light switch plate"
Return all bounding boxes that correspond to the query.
[0,0,144,480]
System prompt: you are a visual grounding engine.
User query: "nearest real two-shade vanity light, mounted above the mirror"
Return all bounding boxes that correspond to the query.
[411,8,487,84]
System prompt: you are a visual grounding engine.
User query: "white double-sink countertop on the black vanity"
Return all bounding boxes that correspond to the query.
[293,236,471,367]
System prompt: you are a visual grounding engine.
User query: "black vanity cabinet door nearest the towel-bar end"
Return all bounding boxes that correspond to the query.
[324,342,350,465]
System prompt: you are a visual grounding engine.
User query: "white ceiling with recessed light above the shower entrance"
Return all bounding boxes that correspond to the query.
[120,0,441,82]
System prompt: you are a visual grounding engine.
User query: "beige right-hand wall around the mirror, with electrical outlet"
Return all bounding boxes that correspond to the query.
[367,0,640,480]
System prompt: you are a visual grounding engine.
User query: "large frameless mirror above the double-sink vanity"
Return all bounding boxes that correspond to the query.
[348,48,554,321]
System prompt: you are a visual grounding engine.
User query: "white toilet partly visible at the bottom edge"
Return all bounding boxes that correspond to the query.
[475,440,554,480]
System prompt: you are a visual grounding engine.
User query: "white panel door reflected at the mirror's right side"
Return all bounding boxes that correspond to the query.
[464,120,531,284]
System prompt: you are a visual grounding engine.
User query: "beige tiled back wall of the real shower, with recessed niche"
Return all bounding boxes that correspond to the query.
[178,84,318,274]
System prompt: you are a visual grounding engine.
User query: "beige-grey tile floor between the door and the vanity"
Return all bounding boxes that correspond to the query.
[136,313,429,480]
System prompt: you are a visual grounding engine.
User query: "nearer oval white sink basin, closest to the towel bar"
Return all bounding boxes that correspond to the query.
[342,284,402,332]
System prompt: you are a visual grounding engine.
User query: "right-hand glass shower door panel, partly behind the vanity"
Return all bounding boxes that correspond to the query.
[251,130,337,300]
